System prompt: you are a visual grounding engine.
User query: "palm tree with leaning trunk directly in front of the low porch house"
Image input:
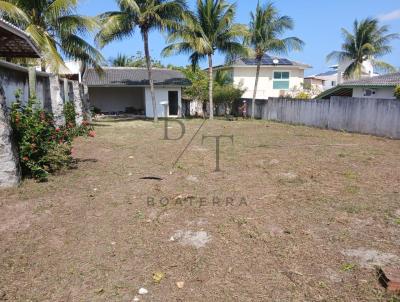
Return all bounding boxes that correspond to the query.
[96,0,186,122]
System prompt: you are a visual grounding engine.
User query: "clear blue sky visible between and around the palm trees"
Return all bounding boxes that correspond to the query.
[79,0,400,75]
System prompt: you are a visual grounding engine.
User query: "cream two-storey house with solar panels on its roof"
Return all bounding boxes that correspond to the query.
[214,54,311,99]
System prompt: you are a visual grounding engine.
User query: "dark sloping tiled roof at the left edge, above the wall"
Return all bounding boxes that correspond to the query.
[0,18,40,58]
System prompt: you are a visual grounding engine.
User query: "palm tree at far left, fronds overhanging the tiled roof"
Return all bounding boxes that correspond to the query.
[0,0,104,73]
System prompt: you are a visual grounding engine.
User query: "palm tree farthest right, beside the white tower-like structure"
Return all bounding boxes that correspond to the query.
[327,18,400,79]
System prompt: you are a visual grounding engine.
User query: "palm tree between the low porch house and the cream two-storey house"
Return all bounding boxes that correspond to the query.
[163,0,247,119]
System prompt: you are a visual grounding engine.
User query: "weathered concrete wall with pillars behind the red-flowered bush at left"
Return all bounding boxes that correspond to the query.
[0,61,90,188]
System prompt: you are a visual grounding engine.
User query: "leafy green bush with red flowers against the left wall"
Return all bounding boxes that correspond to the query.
[11,91,95,181]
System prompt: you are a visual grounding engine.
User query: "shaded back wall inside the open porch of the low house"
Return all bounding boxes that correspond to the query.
[89,87,145,113]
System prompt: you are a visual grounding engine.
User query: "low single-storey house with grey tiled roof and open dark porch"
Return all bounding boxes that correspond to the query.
[83,67,190,117]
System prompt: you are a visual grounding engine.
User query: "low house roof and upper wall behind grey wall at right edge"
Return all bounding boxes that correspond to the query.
[317,72,400,99]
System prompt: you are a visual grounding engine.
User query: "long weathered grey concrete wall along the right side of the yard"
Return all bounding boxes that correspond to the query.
[261,97,400,139]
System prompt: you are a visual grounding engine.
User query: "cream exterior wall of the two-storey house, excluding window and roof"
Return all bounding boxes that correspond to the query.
[233,66,304,99]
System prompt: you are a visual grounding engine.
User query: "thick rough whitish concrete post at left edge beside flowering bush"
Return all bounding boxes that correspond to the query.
[0,86,21,188]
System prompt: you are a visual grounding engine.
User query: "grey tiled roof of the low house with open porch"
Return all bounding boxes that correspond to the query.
[83,67,190,86]
